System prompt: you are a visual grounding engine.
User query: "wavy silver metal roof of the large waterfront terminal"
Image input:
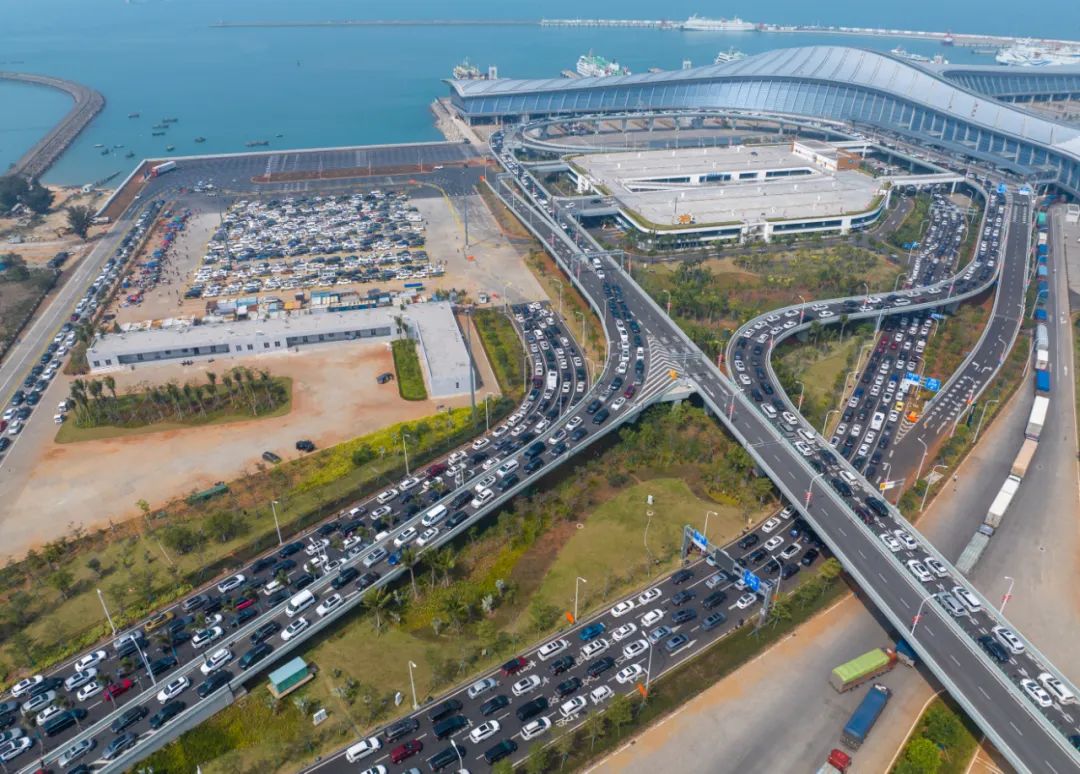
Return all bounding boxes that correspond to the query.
[449,45,1080,157]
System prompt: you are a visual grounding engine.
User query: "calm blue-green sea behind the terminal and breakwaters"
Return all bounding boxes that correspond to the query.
[0,0,1080,184]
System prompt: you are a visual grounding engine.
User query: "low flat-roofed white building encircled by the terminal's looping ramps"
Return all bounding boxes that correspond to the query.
[568,140,890,242]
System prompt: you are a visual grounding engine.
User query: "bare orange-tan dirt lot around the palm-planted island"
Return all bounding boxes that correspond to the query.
[0,337,486,556]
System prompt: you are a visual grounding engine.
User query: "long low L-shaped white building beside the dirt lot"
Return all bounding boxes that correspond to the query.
[86,301,472,397]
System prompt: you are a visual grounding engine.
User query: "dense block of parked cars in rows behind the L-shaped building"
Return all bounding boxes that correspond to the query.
[184,190,444,299]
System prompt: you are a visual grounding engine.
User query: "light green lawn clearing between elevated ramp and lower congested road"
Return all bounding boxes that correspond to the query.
[524,478,744,615]
